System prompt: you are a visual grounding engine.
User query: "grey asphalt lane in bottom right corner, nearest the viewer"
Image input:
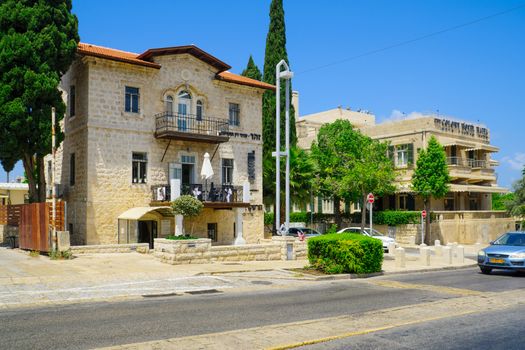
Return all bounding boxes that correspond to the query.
[298,306,525,350]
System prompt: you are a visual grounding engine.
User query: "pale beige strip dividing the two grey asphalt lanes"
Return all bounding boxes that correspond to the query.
[95,289,525,350]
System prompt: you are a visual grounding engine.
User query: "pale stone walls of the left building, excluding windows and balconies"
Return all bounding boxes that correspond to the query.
[51,44,267,245]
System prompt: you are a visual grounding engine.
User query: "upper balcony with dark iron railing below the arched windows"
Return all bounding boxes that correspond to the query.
[155,112,230,143]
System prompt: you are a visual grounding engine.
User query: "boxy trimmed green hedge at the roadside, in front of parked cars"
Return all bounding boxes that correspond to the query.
[308,233,383,274]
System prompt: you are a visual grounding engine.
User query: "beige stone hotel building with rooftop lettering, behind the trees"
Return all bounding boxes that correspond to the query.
[296,104,507,213]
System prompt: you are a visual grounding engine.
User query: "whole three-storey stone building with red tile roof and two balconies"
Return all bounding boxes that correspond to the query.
[52,43,274,245]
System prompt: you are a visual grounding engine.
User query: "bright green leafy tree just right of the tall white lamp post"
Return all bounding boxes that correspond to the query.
[311,119,364,227]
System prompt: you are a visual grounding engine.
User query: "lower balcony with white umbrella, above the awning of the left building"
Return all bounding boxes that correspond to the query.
[151,184,250,209]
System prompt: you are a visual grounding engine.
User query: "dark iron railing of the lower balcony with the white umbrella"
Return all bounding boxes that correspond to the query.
[151,184,243,203]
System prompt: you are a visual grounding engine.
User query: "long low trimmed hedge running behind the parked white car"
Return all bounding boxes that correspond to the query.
[264,210,421,226]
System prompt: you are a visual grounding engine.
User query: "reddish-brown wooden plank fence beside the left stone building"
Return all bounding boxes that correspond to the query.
[0,201,65,252]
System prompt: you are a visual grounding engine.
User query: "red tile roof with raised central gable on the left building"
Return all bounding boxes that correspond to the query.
[77,43,275,90]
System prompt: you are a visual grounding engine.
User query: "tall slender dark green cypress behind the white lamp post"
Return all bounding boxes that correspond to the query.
[262,0,297,229]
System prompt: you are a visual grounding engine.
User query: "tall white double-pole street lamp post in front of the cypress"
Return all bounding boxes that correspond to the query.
[273,60,293,235]
